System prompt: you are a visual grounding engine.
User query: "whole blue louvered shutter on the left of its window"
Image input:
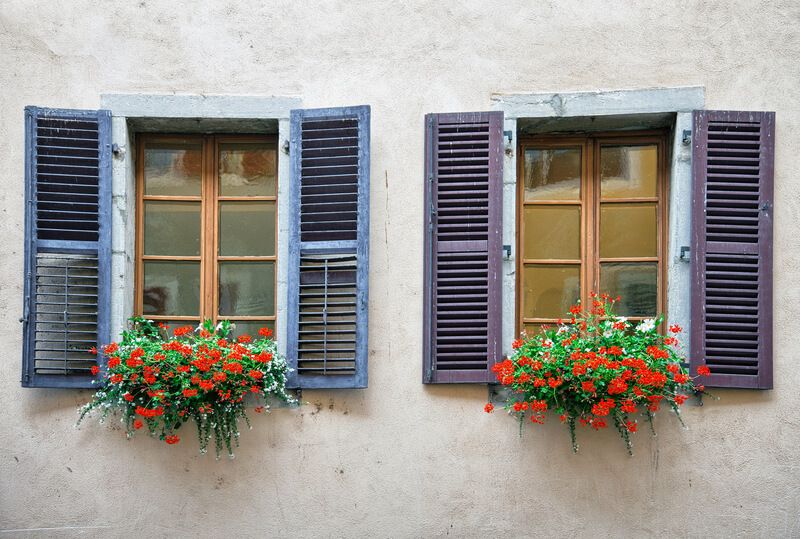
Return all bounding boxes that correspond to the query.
[22,107,111,388]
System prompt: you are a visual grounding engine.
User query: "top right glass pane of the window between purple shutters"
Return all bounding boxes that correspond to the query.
[600,144,658,198]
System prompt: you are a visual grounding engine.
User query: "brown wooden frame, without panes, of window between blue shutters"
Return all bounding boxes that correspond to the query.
[134,133,279,326]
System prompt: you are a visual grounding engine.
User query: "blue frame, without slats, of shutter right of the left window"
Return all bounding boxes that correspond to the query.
[286,105,371,389]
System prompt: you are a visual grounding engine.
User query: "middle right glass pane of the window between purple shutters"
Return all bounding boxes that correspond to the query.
[600,202,658,258]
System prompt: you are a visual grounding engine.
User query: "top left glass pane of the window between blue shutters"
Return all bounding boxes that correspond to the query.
[144,142,203,196]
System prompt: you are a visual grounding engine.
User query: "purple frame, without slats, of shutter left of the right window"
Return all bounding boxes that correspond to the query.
[422,111,503,384]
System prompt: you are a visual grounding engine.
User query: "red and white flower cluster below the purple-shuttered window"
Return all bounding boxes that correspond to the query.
[484,294,710,453]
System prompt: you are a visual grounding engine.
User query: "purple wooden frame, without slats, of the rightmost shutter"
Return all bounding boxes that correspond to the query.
[690,110,775,389]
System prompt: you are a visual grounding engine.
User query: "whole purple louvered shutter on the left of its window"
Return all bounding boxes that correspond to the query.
[423,112,503,383]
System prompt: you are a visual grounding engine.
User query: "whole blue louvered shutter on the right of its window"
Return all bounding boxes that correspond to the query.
[287,106,370,388]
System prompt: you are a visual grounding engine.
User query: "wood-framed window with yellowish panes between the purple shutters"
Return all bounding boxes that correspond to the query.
[517,133,667,331]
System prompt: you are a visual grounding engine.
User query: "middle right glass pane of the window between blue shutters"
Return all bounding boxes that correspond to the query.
[219,202,275,256]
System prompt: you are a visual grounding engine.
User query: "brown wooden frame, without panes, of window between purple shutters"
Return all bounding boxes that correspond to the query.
[515,130,671,335]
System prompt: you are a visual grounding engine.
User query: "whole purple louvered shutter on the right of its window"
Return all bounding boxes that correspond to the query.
[690,110,775,389]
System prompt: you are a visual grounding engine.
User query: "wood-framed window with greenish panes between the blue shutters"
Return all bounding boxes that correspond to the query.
[135,135,278,334]
